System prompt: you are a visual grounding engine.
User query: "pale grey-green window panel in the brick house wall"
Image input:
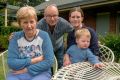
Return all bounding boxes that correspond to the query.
[96,12,110,35]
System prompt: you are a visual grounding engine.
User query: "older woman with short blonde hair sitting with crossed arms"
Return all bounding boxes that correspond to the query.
[7,6,54,80]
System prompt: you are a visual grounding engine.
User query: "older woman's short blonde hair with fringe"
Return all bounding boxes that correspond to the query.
[16,6,37,24]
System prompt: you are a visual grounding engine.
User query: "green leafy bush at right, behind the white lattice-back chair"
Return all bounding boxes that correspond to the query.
[99,33,120,62]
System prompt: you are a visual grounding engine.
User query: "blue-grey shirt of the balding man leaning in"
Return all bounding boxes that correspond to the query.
[37,17,73,51]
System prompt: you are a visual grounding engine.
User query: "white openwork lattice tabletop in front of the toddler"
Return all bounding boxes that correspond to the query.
[52,62,120,80]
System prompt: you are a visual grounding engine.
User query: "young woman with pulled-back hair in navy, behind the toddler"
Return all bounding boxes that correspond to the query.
[67,7,99,56]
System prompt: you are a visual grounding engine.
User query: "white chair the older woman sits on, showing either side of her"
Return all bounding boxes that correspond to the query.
[0,50,58,80]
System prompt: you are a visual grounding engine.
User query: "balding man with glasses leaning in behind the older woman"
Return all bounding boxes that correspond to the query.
[37,4,73,68]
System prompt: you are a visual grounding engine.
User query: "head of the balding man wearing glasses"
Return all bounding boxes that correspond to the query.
[44,5,59,26]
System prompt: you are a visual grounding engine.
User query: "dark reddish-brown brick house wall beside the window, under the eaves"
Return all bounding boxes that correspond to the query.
[60,10,116,33]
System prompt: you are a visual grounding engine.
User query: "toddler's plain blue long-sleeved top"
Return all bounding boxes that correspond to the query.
[66,45,99,64]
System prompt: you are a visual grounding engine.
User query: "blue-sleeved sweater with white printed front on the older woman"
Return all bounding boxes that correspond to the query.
[8,30,54,76]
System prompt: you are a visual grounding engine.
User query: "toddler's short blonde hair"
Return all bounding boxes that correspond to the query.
[75,28,91,39]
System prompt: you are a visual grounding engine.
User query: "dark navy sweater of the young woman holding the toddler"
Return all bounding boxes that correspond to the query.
[67,26,99,56]
